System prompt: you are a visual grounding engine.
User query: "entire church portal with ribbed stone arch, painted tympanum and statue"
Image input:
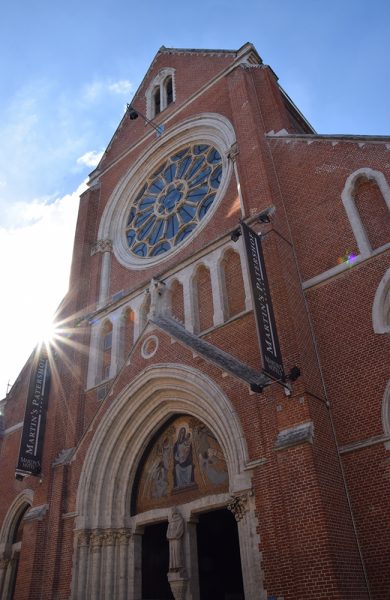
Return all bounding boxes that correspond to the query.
[71,365,265,600]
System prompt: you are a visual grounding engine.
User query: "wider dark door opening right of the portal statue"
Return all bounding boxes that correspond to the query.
[197,509,244,600]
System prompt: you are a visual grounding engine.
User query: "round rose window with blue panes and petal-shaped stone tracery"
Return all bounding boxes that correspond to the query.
[126,144,222,258]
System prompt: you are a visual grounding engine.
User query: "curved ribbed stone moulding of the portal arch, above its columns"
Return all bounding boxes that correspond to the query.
[77,365,249,529]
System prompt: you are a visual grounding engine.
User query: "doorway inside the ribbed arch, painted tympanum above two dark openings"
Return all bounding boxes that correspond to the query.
[132,415,244,600]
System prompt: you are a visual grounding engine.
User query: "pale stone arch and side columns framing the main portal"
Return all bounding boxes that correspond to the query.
[71,364,262,600]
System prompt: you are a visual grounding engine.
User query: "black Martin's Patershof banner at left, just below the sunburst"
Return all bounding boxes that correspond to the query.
[16,351,50,475]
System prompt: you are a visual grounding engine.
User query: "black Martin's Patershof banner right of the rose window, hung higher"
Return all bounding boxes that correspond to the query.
[241,223,284,380]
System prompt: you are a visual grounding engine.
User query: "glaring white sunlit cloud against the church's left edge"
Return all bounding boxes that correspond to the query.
[0,183,85,398]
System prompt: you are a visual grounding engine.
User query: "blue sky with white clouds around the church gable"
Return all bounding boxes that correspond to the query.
[0,0,390,398]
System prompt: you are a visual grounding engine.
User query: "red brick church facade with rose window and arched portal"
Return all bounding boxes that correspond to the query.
[0,44,390,600]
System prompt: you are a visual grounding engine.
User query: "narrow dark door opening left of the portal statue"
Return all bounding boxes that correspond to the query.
[142,523,173,600]
